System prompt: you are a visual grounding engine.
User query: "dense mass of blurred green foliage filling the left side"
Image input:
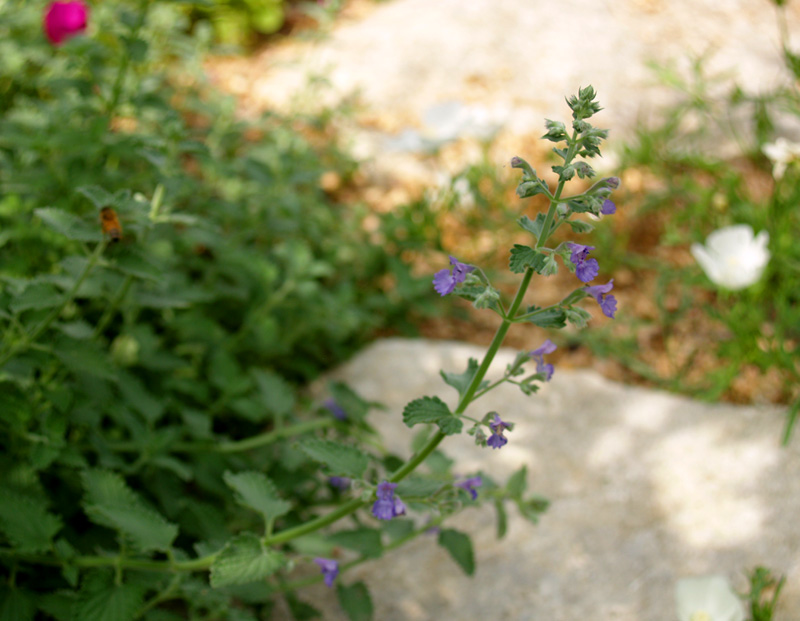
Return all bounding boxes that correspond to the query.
[0,0,456,621]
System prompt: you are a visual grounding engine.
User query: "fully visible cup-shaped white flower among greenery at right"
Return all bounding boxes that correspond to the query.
[692,224,770,291]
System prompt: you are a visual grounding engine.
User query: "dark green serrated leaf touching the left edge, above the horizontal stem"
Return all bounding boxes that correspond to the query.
[0,489,62,553]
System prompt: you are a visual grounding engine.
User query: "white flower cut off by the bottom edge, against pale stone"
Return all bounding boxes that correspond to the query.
[675,576,745,621]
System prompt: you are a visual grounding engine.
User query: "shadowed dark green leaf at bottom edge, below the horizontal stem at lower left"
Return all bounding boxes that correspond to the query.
[73,571,145,621]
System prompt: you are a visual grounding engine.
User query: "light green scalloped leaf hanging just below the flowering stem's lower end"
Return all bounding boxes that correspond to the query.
[210,533,286,589]
